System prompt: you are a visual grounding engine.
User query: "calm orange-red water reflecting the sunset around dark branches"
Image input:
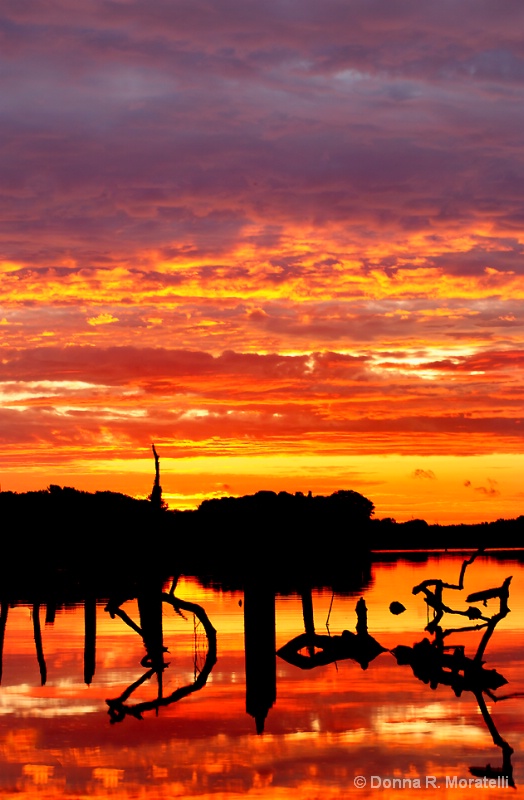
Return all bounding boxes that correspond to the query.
[0,556,524,800]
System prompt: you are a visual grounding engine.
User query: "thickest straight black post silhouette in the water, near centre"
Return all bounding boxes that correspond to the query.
[244,579,277,733]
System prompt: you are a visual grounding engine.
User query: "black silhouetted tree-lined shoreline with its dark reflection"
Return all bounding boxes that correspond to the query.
[0,486,524,593]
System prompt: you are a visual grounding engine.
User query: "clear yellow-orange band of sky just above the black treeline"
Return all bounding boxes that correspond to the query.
[2,444,524,524]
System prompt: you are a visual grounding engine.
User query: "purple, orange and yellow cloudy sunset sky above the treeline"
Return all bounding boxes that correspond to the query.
[0,0,524,523]
